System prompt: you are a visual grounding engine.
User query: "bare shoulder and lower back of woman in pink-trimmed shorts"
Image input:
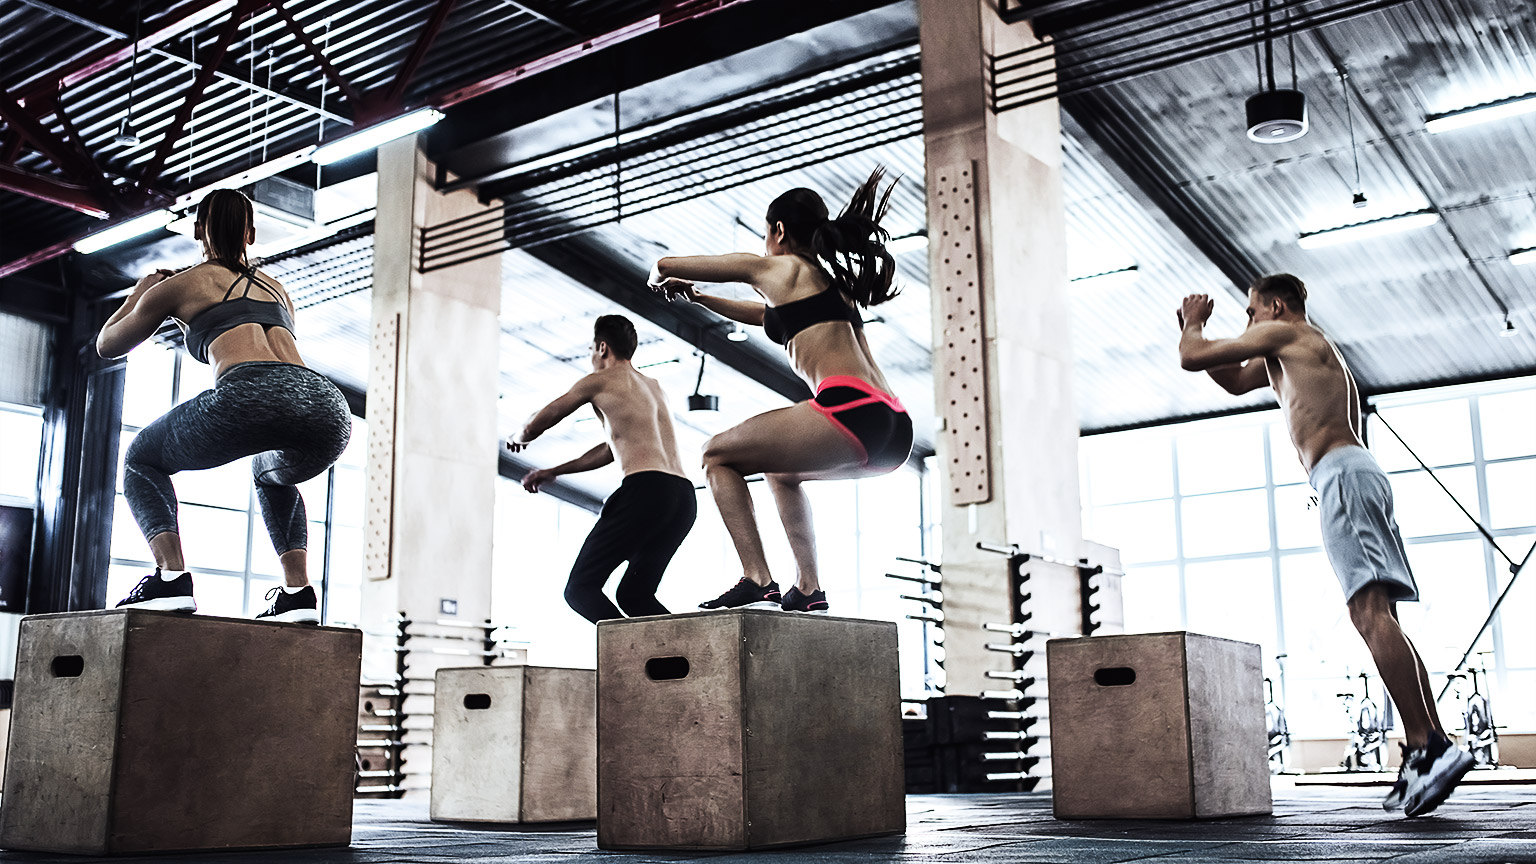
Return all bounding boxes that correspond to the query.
[757,255,891,392]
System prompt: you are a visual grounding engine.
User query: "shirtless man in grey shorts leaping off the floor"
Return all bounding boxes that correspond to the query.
[1178,274,1473,816]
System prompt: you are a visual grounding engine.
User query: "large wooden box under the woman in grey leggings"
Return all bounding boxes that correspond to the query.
[0,610,362,855]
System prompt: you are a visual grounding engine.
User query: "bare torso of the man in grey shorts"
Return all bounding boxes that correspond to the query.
[1264,321,1364,474]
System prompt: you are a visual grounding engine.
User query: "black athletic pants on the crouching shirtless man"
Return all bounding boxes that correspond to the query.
[565,470,699,624]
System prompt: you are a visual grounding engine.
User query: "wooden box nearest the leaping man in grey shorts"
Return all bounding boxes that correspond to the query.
[1046,632,1272,819]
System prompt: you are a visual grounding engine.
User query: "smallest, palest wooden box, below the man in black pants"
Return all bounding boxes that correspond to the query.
[432,666,598,822]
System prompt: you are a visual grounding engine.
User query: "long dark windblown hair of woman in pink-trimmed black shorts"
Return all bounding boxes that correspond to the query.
[768,168,900,306]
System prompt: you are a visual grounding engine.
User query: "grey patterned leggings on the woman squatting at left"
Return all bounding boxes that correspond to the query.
[123,363,352,555]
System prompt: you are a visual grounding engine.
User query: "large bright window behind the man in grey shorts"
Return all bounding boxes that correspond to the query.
[1081,380,1536,736]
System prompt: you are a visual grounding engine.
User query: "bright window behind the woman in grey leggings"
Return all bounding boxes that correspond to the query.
[108,343,367,623]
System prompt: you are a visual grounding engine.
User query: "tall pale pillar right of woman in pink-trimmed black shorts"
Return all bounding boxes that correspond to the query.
[920,0,1083,693]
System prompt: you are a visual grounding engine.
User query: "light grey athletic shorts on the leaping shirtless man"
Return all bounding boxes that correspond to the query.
[1307,446,1419,601]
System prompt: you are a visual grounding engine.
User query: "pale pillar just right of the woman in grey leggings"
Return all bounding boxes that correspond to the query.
[362,137,501,789]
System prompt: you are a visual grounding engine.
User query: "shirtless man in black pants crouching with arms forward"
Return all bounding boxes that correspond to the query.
[507,315,699,624]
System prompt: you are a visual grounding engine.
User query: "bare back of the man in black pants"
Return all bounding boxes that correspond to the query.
[590,364,688,478]
